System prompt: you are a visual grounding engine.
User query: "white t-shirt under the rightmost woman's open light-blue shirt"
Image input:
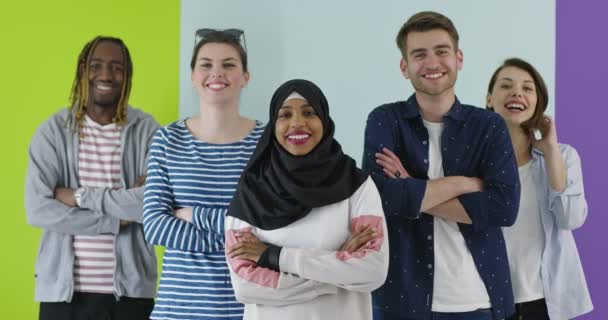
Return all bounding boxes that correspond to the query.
[502,161,545,303]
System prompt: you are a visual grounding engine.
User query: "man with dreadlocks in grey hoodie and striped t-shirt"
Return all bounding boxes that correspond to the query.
[25,37,159,320]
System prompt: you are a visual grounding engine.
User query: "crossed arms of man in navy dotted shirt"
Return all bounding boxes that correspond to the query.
[363,109,520,231]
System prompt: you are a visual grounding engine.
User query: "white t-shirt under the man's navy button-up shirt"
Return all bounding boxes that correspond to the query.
[424,121,491,312]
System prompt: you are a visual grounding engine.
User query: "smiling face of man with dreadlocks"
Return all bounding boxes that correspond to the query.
[88,41,125,108]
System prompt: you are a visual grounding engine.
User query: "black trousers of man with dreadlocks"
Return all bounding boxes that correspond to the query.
[39,292,154,320]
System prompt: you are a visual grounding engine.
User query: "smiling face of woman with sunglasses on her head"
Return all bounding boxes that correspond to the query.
[191,42,249,104]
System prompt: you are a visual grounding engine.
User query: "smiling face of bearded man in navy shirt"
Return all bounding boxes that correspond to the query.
[400,29,463,96]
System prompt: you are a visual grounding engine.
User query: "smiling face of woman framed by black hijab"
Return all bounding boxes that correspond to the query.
[275,98,323,156]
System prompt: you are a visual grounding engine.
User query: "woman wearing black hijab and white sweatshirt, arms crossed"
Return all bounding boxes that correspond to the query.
[225,80,388,320]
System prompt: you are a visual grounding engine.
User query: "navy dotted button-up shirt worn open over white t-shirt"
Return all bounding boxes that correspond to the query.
[363,95,520,319]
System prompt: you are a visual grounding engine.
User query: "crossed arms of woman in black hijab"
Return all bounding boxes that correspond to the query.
[226,180,388,306]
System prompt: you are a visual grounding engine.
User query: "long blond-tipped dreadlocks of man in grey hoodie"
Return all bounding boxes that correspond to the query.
[68,36,133,129]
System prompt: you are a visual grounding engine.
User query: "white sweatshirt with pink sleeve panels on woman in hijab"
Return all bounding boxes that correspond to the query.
[225,178,389,320]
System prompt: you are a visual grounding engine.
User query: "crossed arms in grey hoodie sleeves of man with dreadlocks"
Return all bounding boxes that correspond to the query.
[25,123,152,235]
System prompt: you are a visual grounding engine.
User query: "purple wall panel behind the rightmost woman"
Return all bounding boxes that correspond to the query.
[555,0,608,320]
